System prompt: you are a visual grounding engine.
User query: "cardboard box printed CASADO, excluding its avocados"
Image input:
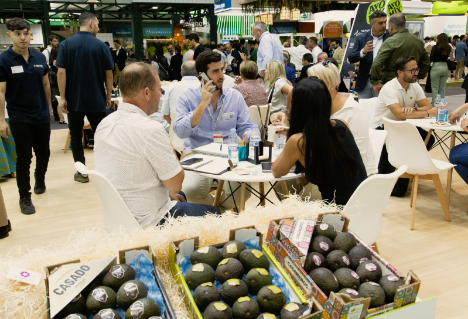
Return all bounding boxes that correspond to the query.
[44,246,176,319]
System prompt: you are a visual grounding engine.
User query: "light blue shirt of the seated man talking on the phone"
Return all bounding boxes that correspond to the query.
[174,88,253,150]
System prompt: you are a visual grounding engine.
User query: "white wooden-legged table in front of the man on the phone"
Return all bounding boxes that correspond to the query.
[198,161,301,212]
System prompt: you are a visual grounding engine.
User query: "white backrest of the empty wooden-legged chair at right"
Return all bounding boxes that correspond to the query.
[383,117,439,175]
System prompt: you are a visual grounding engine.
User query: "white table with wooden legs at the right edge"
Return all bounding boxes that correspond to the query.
[406,118,468,205]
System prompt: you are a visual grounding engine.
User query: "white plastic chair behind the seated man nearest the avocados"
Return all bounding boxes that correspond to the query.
[75,162,142,231]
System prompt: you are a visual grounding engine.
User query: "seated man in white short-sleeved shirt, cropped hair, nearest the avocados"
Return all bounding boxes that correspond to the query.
[94,62,220,227]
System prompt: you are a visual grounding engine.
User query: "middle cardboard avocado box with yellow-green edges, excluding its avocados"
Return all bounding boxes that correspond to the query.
[169,226,323,319]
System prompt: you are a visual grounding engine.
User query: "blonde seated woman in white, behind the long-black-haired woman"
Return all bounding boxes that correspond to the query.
[308,61,379,175]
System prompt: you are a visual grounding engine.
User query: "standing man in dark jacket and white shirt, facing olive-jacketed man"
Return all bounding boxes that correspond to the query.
[348,11,390,99]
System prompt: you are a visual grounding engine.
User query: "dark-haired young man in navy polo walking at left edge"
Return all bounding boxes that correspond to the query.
[0,18,52,215]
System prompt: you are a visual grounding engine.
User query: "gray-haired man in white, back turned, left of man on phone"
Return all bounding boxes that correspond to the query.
[161,60,200,124]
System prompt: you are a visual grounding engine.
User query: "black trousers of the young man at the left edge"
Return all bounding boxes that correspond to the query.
[10,123,50,198]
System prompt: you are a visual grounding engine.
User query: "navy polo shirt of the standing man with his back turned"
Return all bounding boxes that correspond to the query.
[56,31,114,113]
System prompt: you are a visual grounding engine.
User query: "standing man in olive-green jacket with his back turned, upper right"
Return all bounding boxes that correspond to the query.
[370,13,430,94]
